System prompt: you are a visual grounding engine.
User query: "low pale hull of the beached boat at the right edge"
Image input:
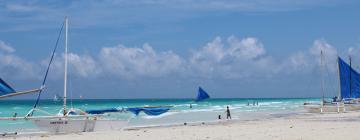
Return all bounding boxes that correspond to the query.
[304,104,360,113]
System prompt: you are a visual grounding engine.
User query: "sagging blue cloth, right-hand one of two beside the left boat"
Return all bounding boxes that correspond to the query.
[126,107,170,116]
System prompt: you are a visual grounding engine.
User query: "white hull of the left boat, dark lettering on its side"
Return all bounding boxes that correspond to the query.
[33,119,96,133]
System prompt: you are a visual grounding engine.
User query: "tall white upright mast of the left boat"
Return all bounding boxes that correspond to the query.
[63,16,68,116]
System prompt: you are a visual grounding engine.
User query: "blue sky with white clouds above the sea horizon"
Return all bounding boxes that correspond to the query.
[0,0,360,99]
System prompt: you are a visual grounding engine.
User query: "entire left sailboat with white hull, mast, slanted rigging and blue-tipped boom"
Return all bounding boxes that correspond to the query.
[0,17,128,133]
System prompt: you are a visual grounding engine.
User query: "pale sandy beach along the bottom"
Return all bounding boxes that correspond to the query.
[0,112,360,140]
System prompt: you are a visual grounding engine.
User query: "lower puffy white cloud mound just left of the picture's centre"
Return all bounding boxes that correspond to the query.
[99,44,182,78]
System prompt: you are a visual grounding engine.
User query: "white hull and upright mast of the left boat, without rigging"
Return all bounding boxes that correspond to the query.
[29,17,128,133]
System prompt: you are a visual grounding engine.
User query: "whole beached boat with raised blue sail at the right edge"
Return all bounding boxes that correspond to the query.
[304,51,360,113]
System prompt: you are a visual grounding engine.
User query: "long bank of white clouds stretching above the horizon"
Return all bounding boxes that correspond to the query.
[0,36,352,79]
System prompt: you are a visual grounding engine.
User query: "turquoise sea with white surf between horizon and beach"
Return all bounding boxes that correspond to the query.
[0,98,320,133]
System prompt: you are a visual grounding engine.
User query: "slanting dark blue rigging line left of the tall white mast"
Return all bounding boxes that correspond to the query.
[28,22,65,116]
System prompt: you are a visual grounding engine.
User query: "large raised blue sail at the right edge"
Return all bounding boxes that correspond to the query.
[338,57,360,99]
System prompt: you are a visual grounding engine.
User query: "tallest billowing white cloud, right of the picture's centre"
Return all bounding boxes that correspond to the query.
[189,36,278,79]
